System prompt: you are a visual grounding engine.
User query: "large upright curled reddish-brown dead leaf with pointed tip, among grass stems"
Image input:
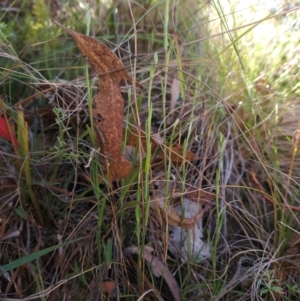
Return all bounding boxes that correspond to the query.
[53,21,141,180]
